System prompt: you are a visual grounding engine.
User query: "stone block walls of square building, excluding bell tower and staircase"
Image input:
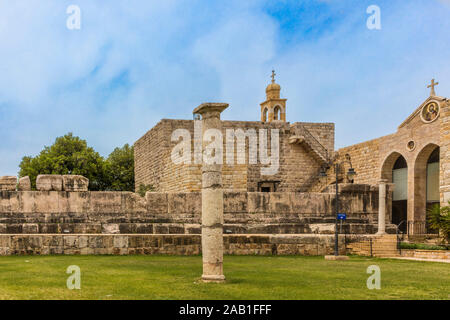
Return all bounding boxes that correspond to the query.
[134,119,334,192]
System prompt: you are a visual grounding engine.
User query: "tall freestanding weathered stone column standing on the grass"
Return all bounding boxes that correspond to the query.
[193,103,228,282]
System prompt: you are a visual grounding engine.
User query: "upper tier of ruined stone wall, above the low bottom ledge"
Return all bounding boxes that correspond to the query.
[0,185,393,234]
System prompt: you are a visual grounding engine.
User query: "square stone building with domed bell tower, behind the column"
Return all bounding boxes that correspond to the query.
[134,81,334,192]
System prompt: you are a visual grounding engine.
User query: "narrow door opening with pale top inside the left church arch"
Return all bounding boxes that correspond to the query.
[392,156,408,232]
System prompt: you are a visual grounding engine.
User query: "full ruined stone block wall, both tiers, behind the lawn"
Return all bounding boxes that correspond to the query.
[0,185,395,255]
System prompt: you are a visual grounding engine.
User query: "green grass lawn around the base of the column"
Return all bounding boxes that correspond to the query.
[0,256,450,299]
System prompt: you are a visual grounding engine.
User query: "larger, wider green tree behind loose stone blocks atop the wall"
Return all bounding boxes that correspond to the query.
[19,133,108,190]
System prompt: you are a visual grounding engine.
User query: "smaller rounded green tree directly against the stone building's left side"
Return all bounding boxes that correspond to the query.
[106,144,134,192]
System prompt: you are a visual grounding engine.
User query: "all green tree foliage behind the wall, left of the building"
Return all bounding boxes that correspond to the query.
[19,133,134,191]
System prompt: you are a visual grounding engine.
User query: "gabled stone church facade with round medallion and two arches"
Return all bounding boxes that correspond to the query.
[336,89,450,233]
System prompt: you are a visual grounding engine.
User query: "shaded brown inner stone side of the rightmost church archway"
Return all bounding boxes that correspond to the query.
[411,143,439,234]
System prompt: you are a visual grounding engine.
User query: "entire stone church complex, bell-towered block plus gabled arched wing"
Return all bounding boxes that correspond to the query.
[134,74,450,233]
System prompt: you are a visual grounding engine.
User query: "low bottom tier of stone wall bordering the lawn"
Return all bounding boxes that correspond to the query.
[0,234,346,256]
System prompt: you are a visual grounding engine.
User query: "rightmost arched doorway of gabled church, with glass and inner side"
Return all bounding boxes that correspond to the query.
[410,143,440,234]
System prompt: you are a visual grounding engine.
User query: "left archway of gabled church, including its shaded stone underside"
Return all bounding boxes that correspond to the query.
[381,152,408,232]
